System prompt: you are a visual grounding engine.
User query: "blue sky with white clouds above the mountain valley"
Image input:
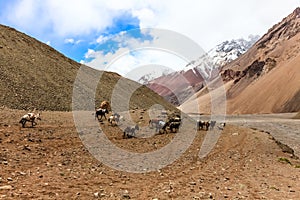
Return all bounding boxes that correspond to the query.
[0,0,300,77]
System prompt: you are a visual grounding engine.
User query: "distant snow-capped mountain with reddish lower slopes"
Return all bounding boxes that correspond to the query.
[145,36,258,105]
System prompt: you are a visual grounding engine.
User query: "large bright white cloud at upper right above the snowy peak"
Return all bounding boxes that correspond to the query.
[134,0,300,51]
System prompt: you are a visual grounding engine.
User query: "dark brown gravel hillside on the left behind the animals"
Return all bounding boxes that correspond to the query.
[0,25,173,111]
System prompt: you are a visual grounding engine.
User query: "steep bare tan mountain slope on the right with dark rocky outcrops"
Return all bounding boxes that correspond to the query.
[181,8,300,113]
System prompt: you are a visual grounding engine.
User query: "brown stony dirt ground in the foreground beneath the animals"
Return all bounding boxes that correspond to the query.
[0,110,300,200]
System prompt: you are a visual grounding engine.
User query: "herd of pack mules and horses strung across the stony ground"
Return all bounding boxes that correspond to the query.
[19,101,225,138]
